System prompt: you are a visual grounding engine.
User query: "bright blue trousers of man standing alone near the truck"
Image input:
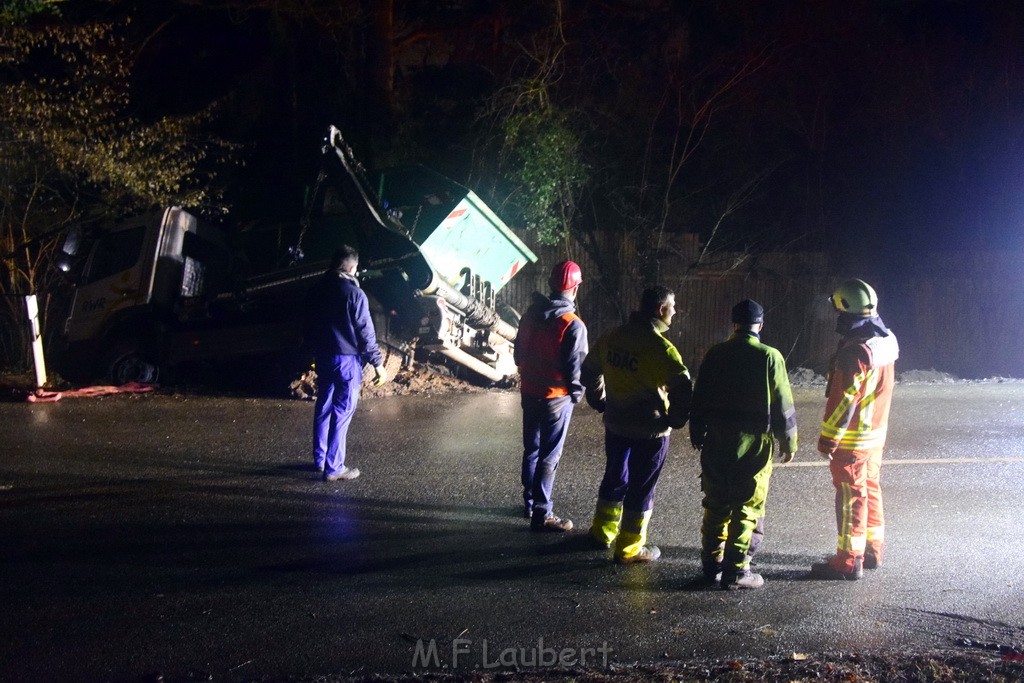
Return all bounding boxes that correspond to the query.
[313,355,362,474]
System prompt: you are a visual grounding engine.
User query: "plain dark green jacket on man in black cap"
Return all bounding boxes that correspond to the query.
[690,332,797,453]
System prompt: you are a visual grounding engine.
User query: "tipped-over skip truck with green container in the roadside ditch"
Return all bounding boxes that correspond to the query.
[60,126,537,387]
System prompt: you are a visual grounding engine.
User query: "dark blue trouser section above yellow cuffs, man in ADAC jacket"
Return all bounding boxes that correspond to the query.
[597,430,669,513]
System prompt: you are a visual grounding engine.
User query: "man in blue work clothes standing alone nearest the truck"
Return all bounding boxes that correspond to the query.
[306,245,387,481]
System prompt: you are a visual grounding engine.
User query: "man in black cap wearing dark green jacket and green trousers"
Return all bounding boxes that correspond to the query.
[690,299,797,590]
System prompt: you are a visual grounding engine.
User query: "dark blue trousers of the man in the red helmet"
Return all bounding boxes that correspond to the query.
[520,396,572,518]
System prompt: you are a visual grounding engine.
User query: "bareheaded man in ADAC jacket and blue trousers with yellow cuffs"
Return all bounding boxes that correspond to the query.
[583,287,692,564]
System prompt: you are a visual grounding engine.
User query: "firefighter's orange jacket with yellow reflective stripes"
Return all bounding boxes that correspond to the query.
[818,332,899,453]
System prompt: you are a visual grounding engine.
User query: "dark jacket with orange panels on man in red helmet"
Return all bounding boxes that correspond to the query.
[513,292,588,403]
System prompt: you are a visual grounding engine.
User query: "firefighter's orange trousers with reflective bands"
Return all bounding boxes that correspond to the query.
[829,446,886,573]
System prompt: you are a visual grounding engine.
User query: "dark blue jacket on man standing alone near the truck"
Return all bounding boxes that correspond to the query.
[305,270,384,367]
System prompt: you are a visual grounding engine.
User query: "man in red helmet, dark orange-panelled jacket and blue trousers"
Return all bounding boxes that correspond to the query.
[514,261,587,531]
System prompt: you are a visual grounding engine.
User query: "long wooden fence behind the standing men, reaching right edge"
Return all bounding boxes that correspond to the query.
[501,234,1024,378]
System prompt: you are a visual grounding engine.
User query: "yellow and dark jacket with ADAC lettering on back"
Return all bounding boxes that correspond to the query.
[582,313,692,438]
